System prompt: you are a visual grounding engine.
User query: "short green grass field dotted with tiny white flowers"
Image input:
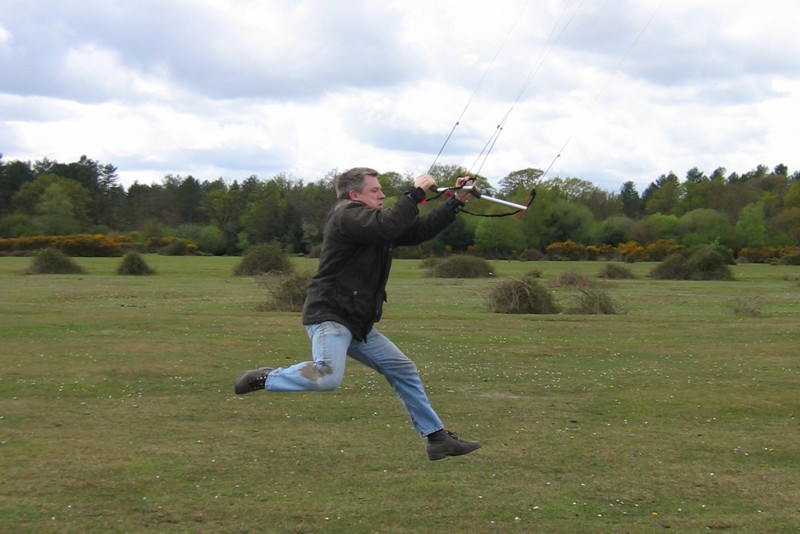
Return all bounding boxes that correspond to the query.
[0,256,800,533]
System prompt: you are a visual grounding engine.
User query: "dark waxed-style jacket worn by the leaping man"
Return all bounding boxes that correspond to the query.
[303,189,464,340]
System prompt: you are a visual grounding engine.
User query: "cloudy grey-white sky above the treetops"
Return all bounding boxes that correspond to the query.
[0,0,800,191]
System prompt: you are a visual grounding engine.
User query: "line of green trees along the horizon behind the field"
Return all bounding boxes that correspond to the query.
[0,156,800,257]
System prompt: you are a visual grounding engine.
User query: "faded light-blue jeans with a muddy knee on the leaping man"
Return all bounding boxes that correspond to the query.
[264,321,443,436]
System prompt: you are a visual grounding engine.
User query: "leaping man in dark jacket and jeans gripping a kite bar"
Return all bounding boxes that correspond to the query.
[234,167,480,460]
